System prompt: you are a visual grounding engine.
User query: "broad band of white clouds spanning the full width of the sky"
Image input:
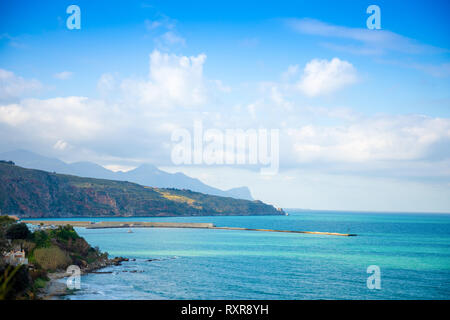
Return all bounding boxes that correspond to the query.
[0,50,450,182]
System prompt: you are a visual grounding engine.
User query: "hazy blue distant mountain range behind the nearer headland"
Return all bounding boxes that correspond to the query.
[0,150,253,200]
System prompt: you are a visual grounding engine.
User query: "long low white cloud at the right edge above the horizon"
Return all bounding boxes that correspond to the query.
[286,115,450,165]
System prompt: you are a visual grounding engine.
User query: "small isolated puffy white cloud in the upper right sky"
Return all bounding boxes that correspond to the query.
[298,58,357,97]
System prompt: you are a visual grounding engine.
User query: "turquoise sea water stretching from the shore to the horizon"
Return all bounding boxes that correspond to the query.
[31,210,450,299]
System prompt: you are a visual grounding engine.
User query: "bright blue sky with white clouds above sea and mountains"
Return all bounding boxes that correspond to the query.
[0,0,450,212]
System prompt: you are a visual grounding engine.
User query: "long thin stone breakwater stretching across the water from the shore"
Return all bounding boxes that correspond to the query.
[22,220,356,237]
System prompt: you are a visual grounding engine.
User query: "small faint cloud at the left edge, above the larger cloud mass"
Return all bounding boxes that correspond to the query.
[0,69,42,101]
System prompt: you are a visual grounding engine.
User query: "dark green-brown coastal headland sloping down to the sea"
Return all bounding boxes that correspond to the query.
[0,162,284,218]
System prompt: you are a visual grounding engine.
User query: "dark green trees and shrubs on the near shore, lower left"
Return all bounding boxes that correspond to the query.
[0,220,108,300]
